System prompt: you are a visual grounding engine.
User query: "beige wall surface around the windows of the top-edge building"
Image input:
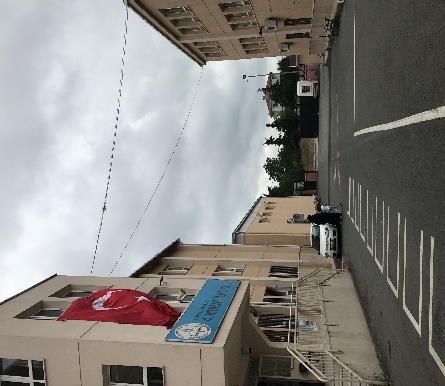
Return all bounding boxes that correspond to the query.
[129,0,334,64]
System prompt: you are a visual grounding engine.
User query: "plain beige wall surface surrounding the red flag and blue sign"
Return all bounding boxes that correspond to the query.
[0,276,249,386]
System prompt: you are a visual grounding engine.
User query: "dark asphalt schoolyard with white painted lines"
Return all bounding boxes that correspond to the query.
[319,0,445,386]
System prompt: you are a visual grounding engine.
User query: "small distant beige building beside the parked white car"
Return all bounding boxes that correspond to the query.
[232,196,315,246]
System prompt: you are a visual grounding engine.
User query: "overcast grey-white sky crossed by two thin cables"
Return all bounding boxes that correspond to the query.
[0,0,276,299]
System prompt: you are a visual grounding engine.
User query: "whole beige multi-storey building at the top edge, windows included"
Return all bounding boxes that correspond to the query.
[128,0,339,65]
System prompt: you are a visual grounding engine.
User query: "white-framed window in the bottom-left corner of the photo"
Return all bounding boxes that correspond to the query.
[0,358,45,386]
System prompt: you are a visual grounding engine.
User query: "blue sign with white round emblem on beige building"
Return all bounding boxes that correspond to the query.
[165,279,240,343]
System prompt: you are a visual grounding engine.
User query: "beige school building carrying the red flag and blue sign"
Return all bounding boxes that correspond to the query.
[0,240,385,386]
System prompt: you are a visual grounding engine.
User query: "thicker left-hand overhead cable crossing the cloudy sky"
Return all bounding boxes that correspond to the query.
[90,0,128,275]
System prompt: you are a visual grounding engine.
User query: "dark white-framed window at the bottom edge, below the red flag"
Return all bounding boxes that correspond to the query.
[104,365,164,386]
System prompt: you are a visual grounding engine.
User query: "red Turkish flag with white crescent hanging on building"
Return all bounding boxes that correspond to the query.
[57,288,181,328]
